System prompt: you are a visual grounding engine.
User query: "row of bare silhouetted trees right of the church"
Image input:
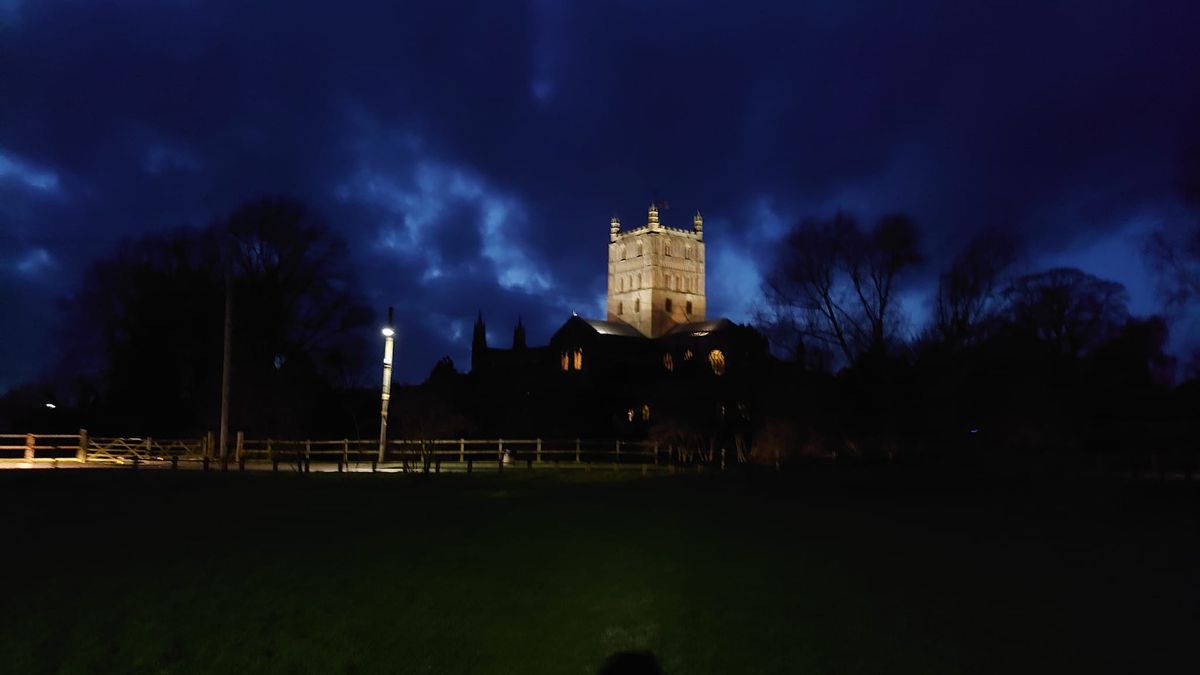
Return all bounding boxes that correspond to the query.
[760,214,1200,468]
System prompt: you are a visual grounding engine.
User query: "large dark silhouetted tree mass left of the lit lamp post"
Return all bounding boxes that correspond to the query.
[56,198,367,434]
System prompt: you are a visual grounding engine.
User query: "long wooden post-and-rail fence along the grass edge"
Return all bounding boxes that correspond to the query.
[0,430,720,473]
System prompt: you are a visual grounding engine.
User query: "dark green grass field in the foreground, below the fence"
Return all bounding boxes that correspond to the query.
[0,471,1200,675]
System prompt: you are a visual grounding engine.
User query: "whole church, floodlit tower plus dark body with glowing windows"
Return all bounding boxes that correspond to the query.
[468,199,769,437]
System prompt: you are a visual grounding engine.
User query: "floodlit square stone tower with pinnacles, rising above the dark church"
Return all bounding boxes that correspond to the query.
[607,204,706,338]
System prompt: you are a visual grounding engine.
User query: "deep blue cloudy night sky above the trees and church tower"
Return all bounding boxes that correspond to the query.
[0,0,1200,392]
